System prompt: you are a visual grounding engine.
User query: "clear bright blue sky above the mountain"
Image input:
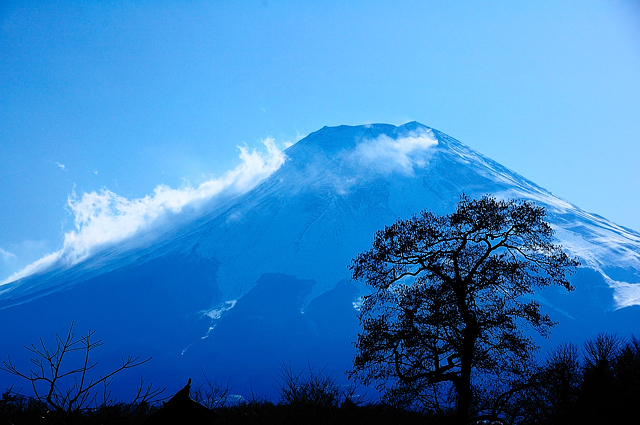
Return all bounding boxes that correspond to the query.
[0,0,640,280]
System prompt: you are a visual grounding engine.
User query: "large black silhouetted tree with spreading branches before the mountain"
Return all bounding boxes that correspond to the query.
[350,196,579,424]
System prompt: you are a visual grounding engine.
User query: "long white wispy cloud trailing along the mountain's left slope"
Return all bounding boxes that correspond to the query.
[0,138,285,283]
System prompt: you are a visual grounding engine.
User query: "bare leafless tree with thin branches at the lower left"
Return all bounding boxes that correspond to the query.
[0,323,164,417]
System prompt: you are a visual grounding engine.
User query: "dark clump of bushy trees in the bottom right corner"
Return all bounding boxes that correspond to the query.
[521,334,640,424]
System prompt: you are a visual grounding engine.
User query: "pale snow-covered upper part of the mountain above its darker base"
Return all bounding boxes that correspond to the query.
[170,123,640,306]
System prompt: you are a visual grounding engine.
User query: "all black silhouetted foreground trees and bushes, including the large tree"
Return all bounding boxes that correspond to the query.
[0,196,640,425]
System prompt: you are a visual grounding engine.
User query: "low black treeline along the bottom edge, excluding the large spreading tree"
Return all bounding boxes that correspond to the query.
[0,334,640,425]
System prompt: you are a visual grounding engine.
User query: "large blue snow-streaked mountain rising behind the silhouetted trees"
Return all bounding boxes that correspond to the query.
[0,122,640,394]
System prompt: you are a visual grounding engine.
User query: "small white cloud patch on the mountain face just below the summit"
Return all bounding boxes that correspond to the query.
[352,130,438,176]
